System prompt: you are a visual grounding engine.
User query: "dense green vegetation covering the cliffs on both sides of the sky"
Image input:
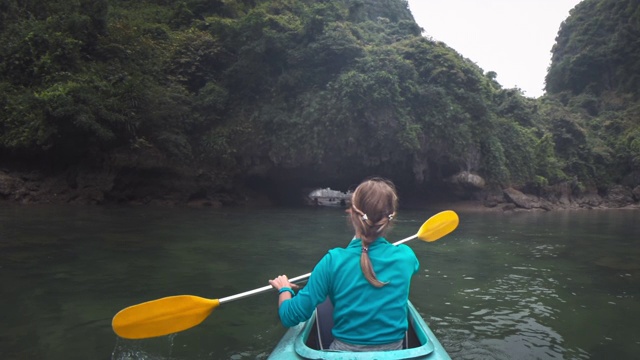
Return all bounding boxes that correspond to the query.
[0,0,640,202]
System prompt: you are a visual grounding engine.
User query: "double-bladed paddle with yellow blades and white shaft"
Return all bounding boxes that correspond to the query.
[111,210,459,339]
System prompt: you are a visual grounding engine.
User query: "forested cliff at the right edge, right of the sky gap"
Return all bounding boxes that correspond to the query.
[544,0,640,190]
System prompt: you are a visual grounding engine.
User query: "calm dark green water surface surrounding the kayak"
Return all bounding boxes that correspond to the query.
[0,204,640,360]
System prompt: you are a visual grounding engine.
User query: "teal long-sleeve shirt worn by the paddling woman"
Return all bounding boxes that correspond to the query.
[278,238,419,345]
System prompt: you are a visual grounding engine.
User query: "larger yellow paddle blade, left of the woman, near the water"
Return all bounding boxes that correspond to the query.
[111,295,220,339]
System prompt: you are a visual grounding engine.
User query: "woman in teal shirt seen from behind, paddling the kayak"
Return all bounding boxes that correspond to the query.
[269,178,419,351]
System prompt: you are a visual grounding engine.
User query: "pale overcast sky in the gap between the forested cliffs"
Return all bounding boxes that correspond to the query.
[409,0,580,97]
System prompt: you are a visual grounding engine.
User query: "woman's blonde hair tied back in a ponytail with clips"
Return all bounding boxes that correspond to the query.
[347,178,398,287]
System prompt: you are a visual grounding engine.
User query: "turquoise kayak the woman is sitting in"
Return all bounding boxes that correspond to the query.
[268,301,451,360]
